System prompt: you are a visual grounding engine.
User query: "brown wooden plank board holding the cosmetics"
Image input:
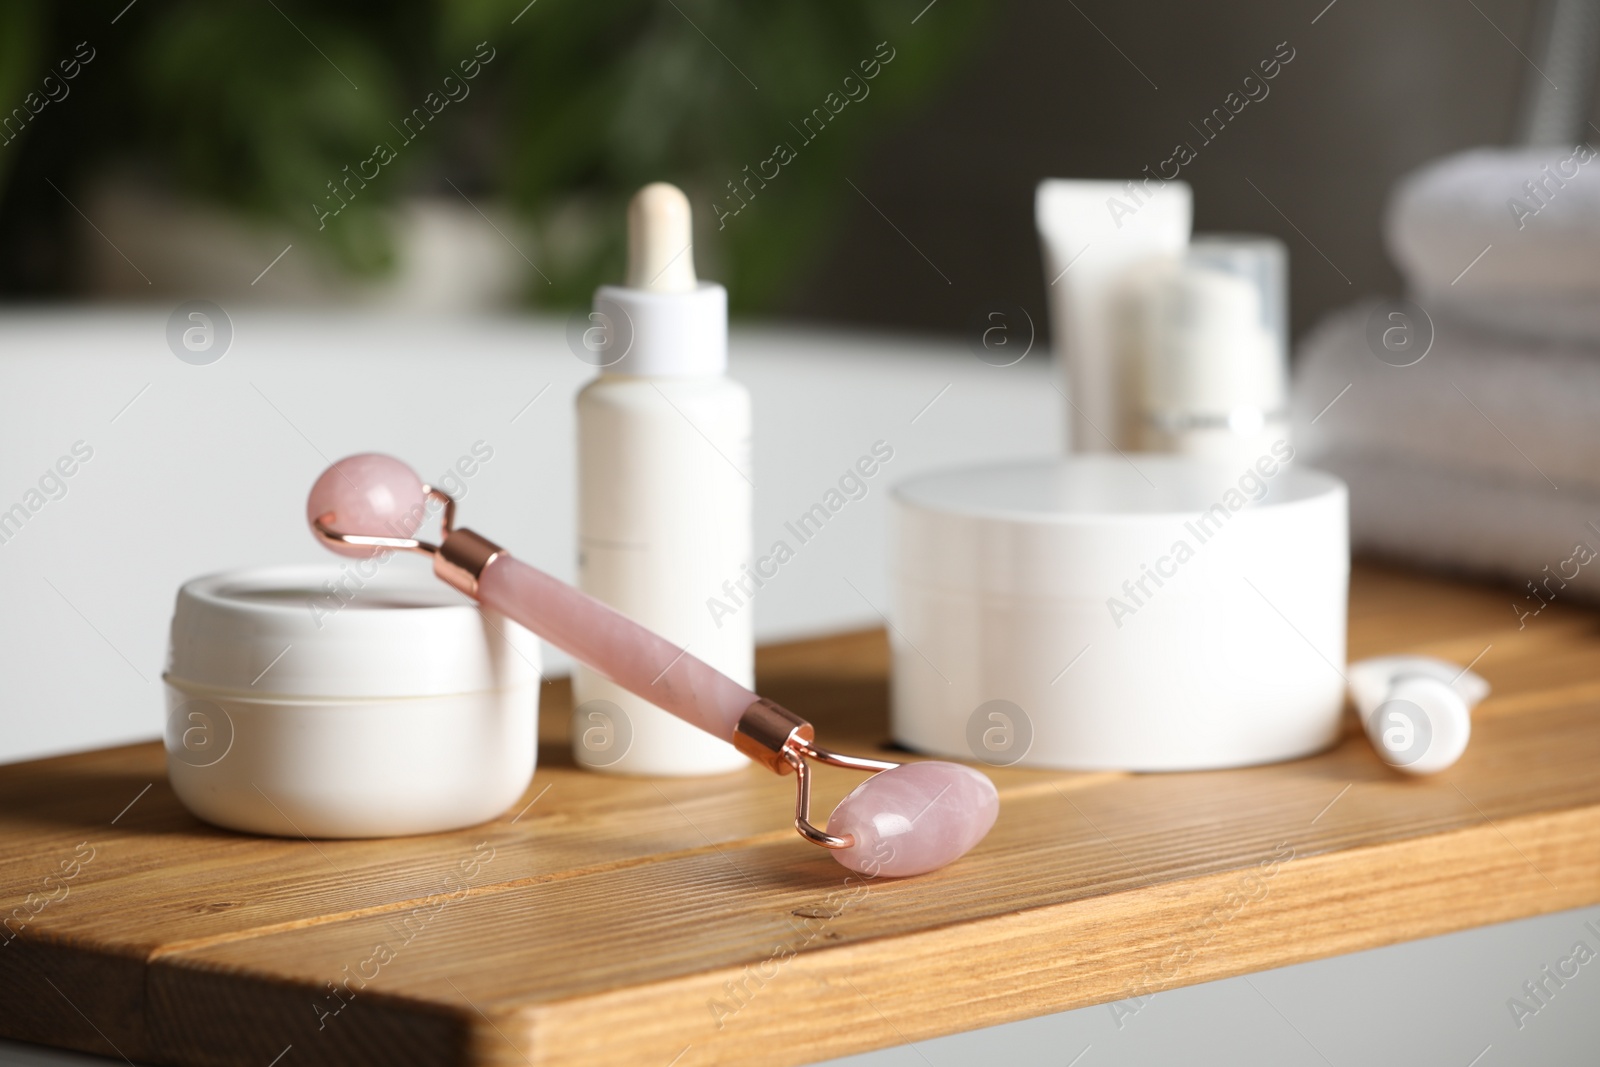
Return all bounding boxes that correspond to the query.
[0,566,1600,1067]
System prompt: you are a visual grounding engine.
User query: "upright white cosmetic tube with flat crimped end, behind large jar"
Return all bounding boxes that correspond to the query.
[1034,178,1194,453]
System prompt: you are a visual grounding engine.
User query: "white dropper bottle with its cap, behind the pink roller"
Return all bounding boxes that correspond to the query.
[573,182,755,776]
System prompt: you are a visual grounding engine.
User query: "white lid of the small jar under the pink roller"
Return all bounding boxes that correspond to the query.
[166,558,539,699]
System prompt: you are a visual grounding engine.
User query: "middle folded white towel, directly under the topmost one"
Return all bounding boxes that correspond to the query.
[1293,304,1600,494]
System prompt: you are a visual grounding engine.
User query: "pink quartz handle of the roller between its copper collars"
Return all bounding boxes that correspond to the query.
[478,555,760,741]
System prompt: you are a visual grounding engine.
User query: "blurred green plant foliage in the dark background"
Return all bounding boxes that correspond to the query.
[0,0,984,310]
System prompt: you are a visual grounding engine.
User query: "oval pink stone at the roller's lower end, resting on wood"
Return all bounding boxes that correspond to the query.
[827,761,1000,878]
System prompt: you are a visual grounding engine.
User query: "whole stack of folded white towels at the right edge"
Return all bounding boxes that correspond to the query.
[1293,146,1600,604]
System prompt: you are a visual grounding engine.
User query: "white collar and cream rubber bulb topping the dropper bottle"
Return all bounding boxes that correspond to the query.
[594,182,728,378]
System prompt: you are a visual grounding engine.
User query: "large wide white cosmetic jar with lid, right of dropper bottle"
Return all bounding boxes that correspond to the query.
[891,454,1350,771]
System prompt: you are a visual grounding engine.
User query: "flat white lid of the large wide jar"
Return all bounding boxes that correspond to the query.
[893,446,1349,605]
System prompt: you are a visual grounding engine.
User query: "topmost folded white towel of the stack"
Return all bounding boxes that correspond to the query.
[1384,144,1600,344]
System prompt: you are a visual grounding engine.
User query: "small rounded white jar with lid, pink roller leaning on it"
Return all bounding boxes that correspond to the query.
[163,560,539,838]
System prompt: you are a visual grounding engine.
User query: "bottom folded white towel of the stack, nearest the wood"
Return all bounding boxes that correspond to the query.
[1317,450,1600,607]
